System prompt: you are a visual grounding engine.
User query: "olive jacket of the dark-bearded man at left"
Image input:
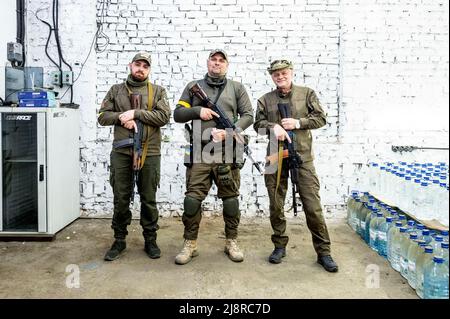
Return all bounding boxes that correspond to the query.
[98,82,170,156]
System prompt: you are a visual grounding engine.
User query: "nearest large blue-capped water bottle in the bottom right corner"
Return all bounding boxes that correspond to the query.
[423,256,448,299]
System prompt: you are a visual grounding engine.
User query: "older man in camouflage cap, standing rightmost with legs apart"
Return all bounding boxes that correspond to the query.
[253,60,338,272]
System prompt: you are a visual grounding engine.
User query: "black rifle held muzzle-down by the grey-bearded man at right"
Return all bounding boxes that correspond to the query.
[278,103,303,216]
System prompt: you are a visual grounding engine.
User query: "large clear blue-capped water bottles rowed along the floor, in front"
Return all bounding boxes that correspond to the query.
[347,191,449,299]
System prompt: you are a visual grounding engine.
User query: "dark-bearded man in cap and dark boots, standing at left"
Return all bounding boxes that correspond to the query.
[98,52,170,261]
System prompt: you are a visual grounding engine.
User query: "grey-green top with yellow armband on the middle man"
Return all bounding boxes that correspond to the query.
[173,75,253,143]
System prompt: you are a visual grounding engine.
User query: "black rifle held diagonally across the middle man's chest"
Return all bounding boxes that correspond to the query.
[190,83,262,174]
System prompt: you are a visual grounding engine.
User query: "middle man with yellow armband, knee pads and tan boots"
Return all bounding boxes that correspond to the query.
[174,49,253,265]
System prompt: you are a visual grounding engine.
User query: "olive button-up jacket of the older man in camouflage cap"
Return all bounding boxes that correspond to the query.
[253,85,326,162]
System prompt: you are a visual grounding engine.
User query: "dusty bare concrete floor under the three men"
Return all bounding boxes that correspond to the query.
[0,217,417,299]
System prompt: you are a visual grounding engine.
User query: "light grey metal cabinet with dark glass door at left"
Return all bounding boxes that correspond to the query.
[0,107,80,240]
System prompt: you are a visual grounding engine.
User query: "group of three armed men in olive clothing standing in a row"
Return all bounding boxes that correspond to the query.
[98,49,338,272]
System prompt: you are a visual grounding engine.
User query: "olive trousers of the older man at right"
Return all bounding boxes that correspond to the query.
[264,161,330,256]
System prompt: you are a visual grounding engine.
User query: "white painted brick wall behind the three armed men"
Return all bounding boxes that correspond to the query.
[22,0,449,218]
